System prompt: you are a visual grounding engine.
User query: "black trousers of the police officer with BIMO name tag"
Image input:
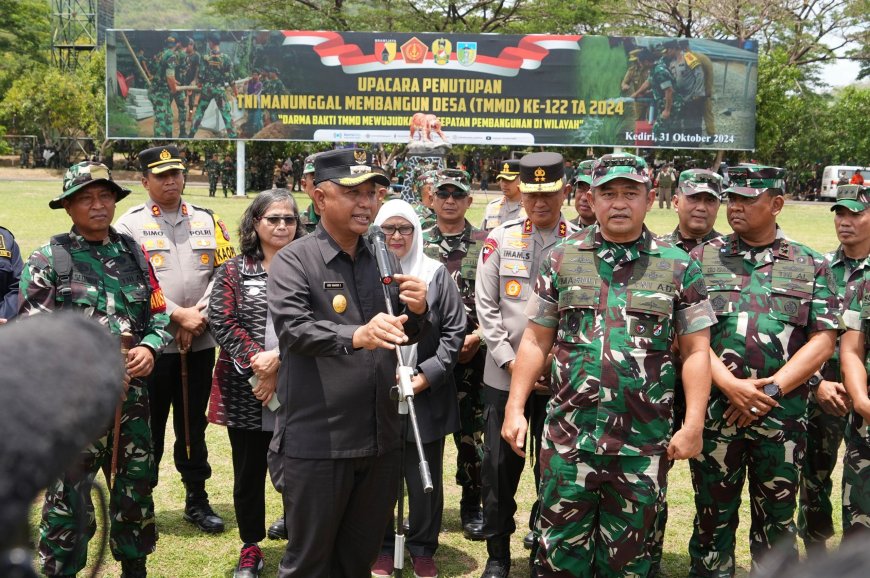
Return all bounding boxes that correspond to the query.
[147,348,215,486]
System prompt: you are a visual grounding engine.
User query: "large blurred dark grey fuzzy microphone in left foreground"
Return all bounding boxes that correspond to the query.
[0,313,124,551]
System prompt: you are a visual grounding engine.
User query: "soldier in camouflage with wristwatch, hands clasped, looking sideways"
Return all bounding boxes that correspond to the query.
[689,167,840,577]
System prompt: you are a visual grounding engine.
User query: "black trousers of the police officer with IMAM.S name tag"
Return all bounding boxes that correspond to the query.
[481,385,550,539]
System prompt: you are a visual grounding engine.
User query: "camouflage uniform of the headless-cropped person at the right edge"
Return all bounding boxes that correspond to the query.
[842,273,870,536]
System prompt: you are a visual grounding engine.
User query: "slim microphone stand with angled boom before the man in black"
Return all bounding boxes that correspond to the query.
[374,256,433,578]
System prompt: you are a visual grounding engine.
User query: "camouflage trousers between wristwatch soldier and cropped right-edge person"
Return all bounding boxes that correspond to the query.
[797,393,847,545]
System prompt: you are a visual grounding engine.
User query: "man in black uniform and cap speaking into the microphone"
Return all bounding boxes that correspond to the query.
[267,149,430,578]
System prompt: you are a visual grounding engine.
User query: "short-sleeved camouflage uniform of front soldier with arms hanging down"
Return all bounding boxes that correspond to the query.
[526,225,715,576]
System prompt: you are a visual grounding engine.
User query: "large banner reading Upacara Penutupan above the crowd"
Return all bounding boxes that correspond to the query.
[106,30,758,149]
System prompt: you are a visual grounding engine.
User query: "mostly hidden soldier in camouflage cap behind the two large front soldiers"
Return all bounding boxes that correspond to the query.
[649,169,722,576]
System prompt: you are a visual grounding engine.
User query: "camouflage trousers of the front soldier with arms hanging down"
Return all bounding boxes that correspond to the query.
[532,441,670,578]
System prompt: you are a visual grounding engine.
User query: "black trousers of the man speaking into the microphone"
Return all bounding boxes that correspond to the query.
[278,450,399,578]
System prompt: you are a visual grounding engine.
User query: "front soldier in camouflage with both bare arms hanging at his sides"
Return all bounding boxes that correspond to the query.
[502,155,715,577]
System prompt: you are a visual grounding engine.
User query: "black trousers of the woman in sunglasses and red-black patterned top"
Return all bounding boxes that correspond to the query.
[227,427,272,544]
